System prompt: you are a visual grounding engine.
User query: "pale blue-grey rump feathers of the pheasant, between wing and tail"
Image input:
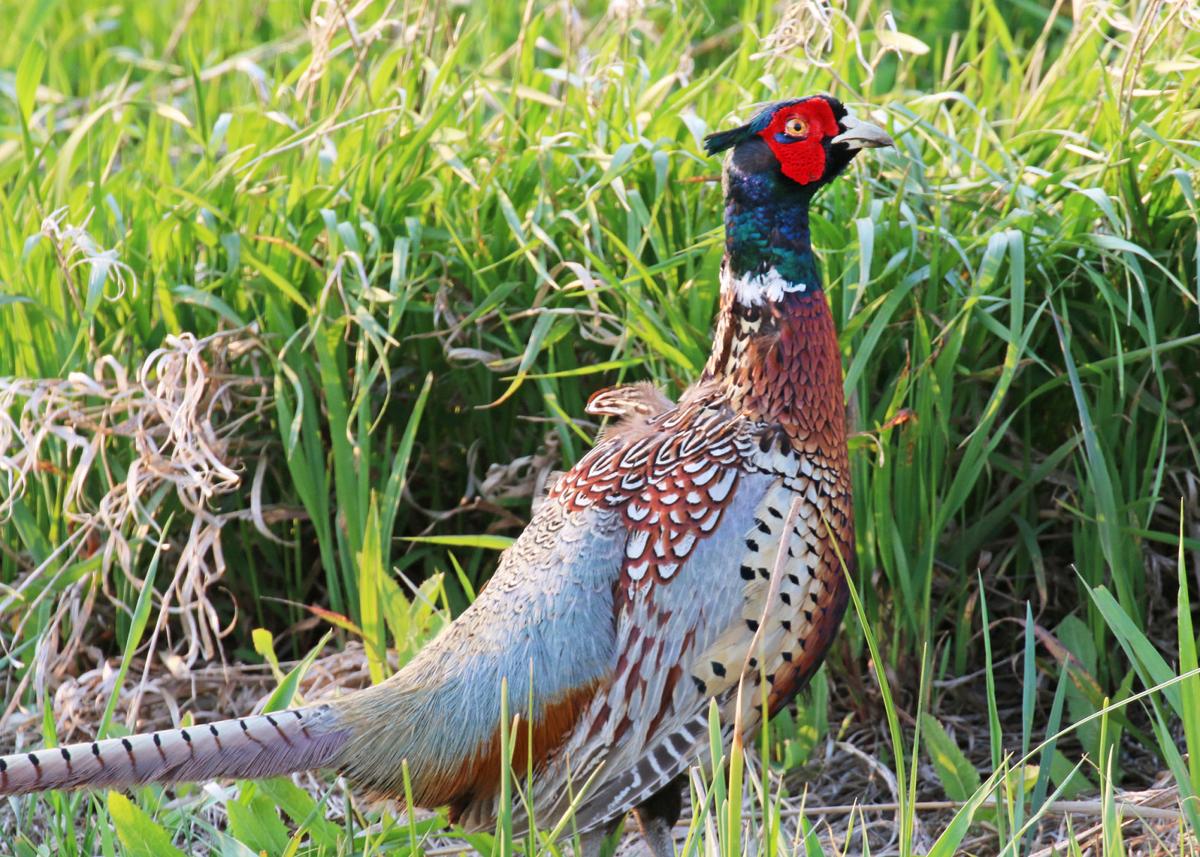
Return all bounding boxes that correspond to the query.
[335,502,625,806]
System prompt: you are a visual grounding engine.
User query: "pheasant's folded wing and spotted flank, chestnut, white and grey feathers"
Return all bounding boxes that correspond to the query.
[525,406,853,829]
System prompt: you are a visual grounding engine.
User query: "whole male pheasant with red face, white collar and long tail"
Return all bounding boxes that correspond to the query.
[0,96,892,857]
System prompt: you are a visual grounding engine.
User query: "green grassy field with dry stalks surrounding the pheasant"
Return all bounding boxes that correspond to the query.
[0,0,1200,857]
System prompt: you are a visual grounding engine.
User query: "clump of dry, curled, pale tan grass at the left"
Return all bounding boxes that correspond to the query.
[0,321,283,667]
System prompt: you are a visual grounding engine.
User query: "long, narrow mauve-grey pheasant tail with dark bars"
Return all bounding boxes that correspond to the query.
[0,705,350,796]
